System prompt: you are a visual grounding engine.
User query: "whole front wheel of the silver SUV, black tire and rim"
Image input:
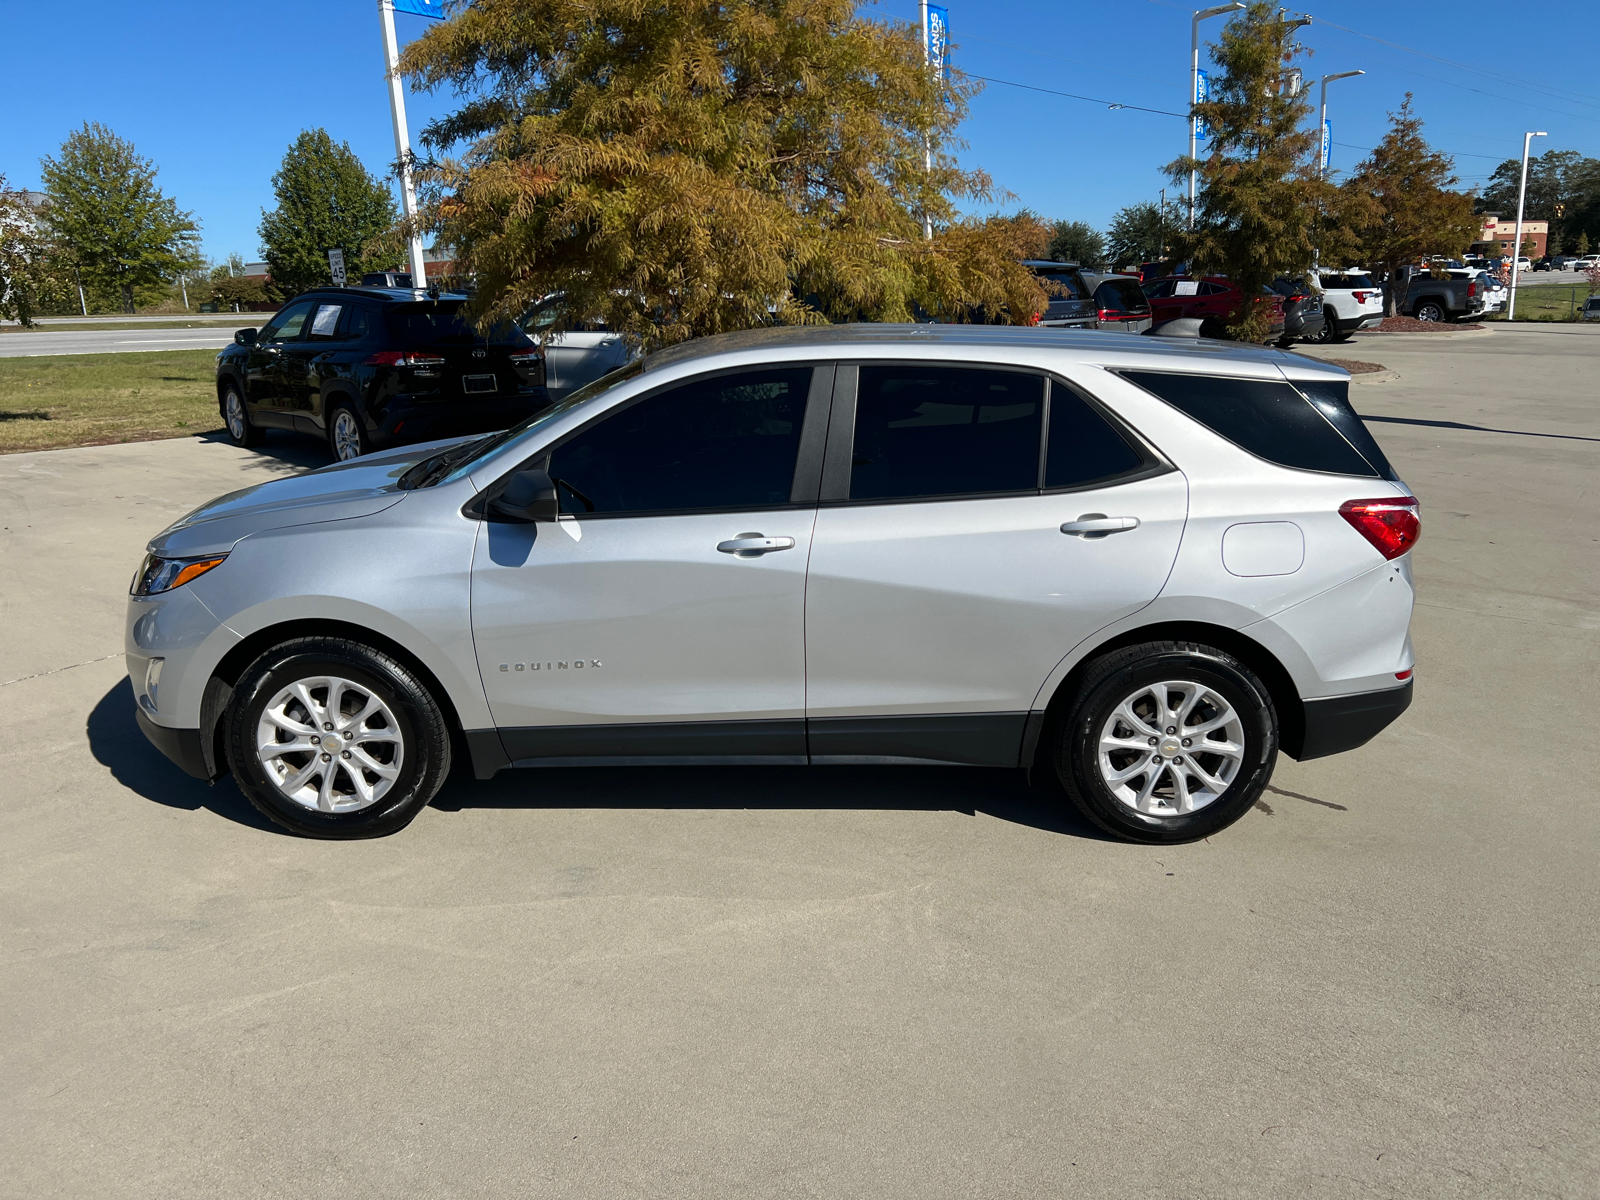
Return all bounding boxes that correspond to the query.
[227,637,450,838]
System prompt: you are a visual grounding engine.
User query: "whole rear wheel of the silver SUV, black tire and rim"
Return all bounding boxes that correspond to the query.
[1054,642,1278,843]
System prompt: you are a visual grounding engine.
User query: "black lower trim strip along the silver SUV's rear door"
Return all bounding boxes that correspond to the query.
[806,712,1027,766]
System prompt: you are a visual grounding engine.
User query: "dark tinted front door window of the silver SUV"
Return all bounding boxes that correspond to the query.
[550,366,811,514]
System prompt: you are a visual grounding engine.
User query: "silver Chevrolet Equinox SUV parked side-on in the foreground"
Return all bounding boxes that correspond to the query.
[126,325,1419,842]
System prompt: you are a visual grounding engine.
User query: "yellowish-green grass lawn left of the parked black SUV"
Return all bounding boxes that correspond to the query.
[0,350,222,454]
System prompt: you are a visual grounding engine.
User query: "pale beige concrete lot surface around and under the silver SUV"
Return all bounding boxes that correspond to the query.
[0,326,1600,1200]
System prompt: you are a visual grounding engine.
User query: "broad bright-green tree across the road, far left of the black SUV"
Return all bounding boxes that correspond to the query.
[40,122,200,312]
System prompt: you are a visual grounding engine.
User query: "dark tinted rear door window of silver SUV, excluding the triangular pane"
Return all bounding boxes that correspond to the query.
[850,365,1045,499]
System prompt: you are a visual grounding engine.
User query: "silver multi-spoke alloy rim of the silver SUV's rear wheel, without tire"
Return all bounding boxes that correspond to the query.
[1098,680,1245,816]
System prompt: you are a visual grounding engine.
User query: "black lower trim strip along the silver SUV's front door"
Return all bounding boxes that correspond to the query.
[499,718,805,766]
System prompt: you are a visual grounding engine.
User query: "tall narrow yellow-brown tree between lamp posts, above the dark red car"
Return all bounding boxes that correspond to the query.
[1166,0,1333,341]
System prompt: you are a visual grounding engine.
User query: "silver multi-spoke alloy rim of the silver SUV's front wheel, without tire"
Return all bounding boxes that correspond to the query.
[256,675,405,813]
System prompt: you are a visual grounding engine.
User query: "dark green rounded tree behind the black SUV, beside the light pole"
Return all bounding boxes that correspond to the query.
[261,130,397,296]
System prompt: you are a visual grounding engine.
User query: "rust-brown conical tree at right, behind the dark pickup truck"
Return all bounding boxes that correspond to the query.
[1342,93,1478,317]
